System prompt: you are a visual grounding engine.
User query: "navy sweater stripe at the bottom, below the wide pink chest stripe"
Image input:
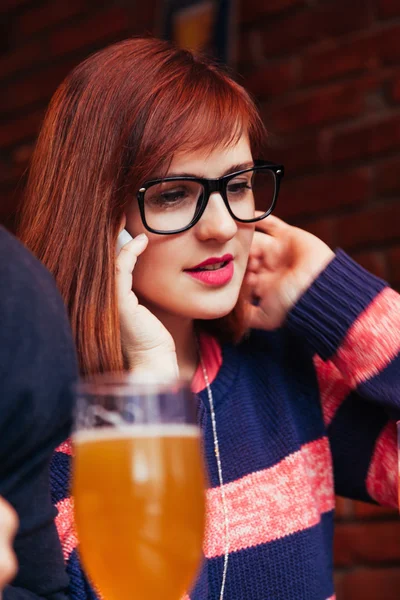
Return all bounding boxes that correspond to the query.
[190,512,334,600]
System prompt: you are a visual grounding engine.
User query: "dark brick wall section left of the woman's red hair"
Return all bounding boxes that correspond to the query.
[0,0,160,229]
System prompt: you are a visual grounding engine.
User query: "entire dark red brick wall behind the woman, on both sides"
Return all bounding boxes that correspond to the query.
[0,0,400,600]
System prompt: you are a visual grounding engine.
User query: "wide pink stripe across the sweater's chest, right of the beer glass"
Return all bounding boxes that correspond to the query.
[204,437,334,558]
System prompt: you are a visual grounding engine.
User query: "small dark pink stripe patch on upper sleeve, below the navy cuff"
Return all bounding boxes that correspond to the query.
[313,355,351,426]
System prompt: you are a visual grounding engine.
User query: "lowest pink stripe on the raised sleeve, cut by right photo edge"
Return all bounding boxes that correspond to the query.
[367,422,400,508]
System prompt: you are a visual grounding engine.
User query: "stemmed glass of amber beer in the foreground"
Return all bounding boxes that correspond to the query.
[73,374,206,600]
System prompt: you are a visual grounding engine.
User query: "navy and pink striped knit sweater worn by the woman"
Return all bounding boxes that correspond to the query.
[52,251,400,600]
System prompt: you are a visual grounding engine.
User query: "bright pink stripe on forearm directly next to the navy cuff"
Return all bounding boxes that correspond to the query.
[333,288,400,387]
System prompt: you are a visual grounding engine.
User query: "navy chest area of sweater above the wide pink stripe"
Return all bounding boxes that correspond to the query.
[200,330,326,486]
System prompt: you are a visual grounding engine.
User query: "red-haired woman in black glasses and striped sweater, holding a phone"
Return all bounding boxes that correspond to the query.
[20,39,400,600]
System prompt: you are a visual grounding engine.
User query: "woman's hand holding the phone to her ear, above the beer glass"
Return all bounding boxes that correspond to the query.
[116,234,179,379]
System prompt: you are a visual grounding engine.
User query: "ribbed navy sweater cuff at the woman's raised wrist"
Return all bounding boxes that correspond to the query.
[287,250,387,360]
